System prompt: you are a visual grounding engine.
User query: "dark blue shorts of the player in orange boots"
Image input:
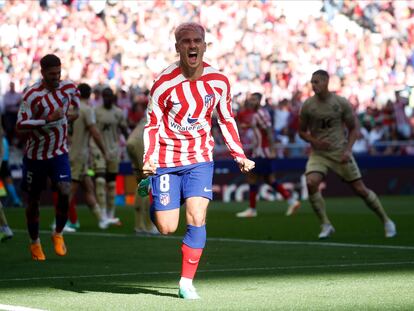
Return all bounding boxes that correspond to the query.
[22,153,72,194]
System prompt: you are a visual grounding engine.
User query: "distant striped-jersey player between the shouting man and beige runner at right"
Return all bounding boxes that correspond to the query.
[236,93,300,217]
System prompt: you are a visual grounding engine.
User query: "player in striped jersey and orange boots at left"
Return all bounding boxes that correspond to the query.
[17,54,79,260]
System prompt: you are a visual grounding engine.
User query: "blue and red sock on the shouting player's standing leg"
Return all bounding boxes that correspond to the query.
[181,225,206,280]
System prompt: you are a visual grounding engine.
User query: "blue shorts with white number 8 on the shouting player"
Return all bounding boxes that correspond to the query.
[151,162,214,211]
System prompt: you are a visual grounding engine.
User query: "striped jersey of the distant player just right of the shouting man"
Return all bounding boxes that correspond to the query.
[252,108,272,158]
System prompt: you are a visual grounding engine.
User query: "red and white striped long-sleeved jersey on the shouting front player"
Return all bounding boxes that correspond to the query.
[144,63,246,167]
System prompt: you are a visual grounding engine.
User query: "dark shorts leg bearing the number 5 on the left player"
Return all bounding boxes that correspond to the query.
[21,157,48,196]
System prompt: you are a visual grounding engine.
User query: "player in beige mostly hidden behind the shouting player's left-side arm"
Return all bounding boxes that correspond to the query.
[127,113,159,234]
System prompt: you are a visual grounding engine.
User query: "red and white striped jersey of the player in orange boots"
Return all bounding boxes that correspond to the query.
[17,80,80,160]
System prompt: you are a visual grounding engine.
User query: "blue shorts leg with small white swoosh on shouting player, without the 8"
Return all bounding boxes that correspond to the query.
[181,162,214,200]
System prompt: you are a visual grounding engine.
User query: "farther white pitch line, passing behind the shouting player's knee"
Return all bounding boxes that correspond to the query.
[14,229,414,250]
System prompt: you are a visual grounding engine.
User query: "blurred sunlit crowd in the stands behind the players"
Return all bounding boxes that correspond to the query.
[0,0,414,157]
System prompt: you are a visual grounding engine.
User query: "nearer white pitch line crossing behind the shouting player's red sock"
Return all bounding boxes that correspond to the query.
[0,261,414,282]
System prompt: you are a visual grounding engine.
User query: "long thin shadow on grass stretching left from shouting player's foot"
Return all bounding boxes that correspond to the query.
[52,281,178,298]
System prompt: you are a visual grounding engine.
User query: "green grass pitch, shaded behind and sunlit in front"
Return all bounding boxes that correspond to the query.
[0,196,414,311]
